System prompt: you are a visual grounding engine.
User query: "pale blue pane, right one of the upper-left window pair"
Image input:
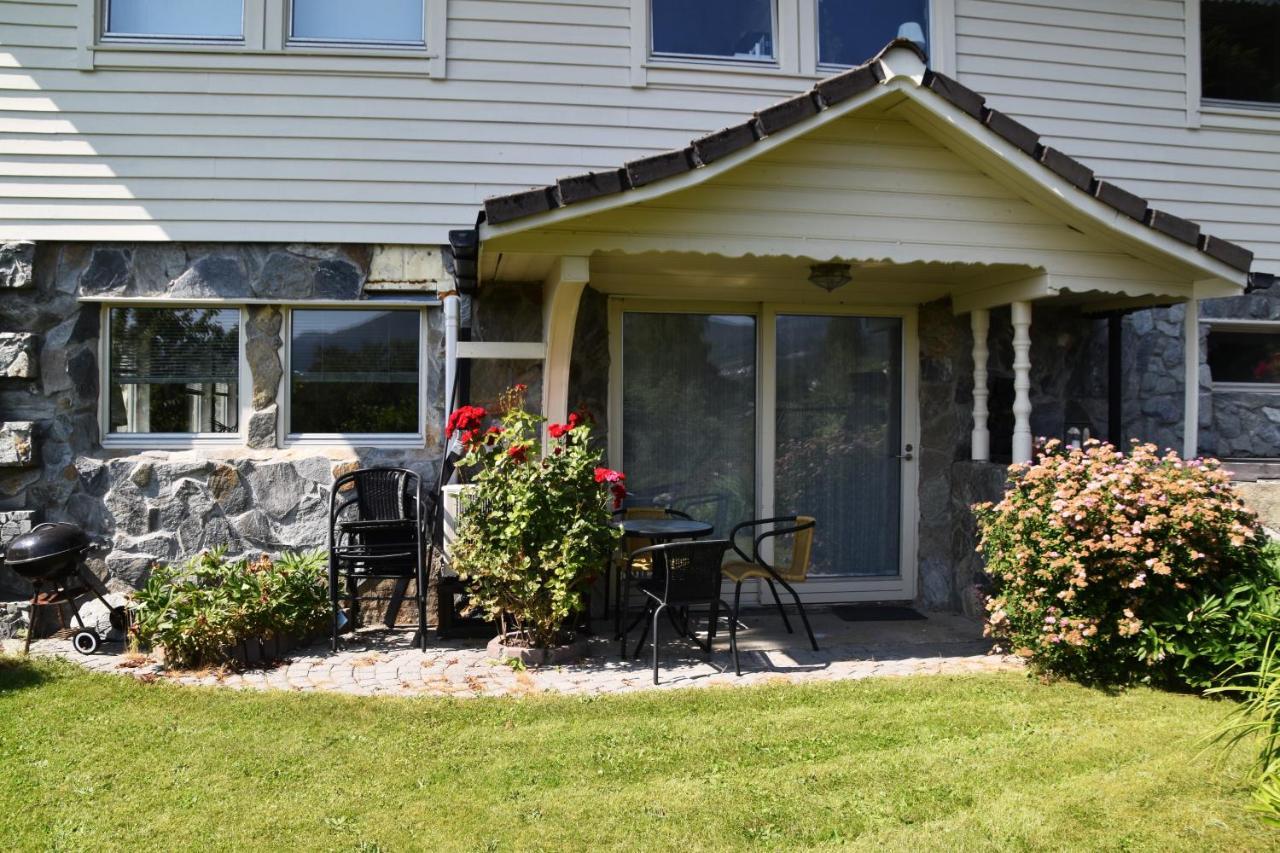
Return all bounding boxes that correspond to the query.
[289,0,426,46]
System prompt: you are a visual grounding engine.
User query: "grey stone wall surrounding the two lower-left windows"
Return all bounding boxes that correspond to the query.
[0,243,444,593]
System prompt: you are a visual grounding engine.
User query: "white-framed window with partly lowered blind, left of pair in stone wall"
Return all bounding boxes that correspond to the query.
[99,305,251,448]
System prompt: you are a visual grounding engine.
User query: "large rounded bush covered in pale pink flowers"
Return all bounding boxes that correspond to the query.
[974,441,1276,686]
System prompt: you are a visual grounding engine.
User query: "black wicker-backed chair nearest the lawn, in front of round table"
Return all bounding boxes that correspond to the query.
[621,539,737,684]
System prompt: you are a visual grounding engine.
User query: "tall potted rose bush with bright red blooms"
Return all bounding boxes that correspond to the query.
[447,386,626,663]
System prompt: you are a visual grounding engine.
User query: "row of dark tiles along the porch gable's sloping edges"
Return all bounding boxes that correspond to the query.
[483,38,1253,273]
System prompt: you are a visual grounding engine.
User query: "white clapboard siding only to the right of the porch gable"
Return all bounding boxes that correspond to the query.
[956,0,1280,273]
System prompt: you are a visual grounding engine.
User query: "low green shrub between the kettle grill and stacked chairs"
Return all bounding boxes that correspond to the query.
[133,549,329,667]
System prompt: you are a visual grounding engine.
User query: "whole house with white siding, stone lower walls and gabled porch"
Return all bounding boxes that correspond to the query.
[0,0,1280,608]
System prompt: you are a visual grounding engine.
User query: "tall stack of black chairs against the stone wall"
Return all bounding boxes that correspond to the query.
[329,467,429,651]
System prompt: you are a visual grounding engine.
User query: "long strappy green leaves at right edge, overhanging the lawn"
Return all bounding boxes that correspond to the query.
[1210,620,1280,826]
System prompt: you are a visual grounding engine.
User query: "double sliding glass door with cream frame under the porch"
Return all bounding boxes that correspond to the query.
[611,301,915,601]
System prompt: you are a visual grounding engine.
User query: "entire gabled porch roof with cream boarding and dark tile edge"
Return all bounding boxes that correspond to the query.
[471,41,1252,311]
